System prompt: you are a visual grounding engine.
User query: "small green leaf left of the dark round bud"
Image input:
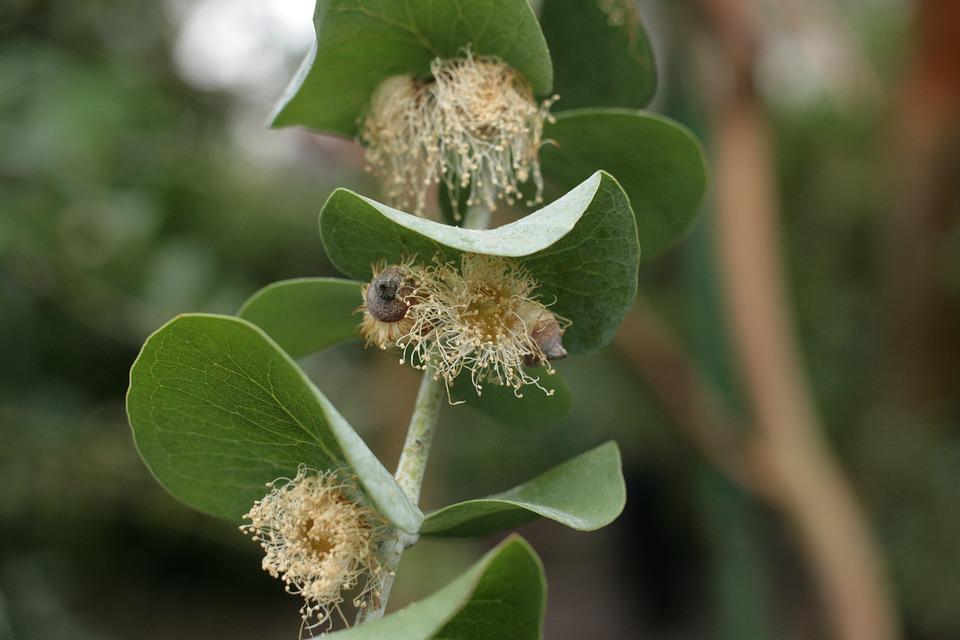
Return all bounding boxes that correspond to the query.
[237,278,363,358]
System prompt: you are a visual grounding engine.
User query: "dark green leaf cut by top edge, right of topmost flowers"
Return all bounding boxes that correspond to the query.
[540,0,657,109]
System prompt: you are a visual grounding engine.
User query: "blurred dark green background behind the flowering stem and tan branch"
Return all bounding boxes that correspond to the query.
[0,0,960,640]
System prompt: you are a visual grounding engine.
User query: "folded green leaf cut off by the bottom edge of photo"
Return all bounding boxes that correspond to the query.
[330,536,547,640]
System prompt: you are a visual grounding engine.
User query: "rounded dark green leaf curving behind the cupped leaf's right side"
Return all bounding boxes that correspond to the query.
[540,109,707,262]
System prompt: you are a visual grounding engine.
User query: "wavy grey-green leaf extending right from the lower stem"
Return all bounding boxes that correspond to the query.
[420,441,626,537]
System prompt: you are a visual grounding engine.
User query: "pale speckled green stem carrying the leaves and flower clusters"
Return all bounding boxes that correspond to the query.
[357,206,490,625]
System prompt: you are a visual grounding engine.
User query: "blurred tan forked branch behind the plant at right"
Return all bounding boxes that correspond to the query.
[621,0,899,640]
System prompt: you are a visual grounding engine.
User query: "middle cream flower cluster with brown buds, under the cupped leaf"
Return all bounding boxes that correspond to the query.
[361,254,569,397]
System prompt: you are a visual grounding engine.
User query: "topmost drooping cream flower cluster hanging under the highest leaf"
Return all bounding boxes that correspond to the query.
[360,50,556,215]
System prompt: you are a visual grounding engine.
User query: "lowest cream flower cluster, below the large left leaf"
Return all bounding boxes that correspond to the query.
[240,465,388,635]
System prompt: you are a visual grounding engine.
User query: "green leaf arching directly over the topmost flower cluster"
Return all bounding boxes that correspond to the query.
[272,0,553,136]
